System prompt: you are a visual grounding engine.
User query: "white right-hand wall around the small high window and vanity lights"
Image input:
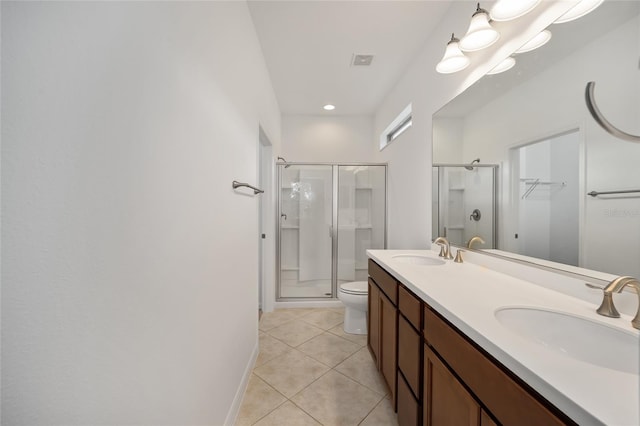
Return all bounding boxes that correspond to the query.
[374,1,571,249]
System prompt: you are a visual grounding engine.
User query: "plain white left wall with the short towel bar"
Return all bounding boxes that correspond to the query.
[2,2,280,425]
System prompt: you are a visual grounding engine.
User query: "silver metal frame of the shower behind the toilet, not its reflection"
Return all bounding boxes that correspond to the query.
[275,161,389,302]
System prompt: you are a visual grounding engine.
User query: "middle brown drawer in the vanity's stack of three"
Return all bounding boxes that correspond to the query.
[398,315,422,398]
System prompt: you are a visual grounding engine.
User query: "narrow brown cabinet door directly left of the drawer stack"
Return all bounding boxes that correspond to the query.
[380,293,398,410]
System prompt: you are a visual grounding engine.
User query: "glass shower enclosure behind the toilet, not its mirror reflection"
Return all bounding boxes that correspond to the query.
[276,163,387,301]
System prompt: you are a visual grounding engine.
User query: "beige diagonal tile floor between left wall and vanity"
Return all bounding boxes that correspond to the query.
[236,308,398,426]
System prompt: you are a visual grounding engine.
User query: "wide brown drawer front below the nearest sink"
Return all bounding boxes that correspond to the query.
[424,309,575,426]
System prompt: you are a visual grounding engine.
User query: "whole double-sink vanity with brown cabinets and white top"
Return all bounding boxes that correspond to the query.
[368,250,640,426]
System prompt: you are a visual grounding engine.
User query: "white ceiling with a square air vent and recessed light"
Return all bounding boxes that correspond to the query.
[248,0,453,115]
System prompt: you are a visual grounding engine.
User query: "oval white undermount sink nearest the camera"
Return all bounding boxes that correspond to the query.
[495,307,640,374]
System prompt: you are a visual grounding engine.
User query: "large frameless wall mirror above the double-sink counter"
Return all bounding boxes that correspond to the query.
[433,0,640,277]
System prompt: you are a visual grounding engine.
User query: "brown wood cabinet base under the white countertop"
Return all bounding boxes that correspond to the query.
[367,260,575,426]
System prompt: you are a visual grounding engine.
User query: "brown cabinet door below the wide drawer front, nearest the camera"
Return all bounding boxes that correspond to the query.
[423,345,480,426]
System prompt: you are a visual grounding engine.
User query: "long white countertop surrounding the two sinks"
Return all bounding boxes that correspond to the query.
[367,250,640,426]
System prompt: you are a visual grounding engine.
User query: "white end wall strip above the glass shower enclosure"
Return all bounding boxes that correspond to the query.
[280,115,375,163]
